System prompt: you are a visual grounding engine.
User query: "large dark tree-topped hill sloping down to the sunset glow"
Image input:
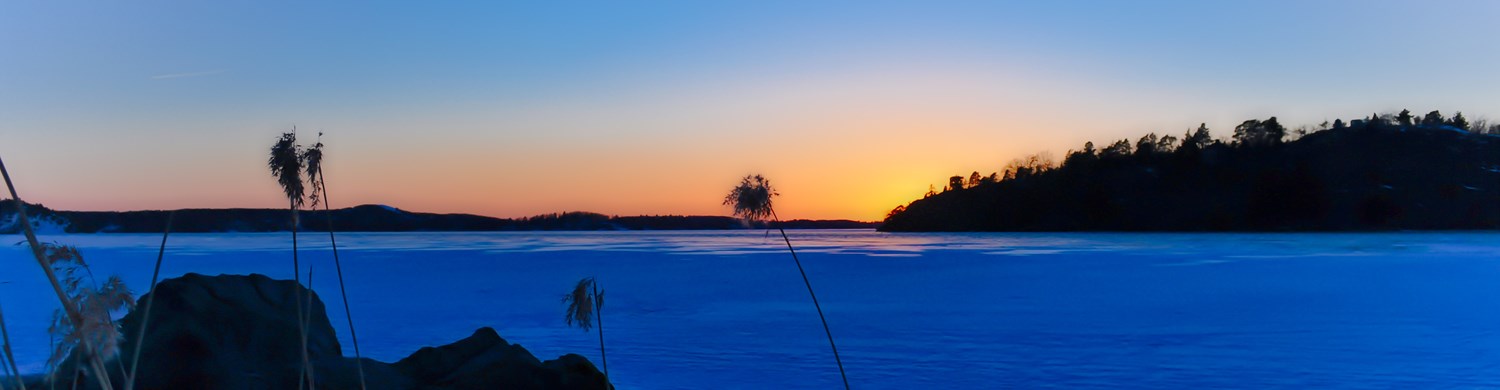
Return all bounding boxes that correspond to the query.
[881,111,1500,231]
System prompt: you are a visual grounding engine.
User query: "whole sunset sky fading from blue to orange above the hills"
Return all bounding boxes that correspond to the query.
[0,0,1500,221]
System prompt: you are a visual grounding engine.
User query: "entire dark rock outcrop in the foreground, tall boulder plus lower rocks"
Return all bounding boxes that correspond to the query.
[43,273,614,390]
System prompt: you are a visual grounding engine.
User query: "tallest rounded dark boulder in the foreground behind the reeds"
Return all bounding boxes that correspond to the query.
[120,273,344,389]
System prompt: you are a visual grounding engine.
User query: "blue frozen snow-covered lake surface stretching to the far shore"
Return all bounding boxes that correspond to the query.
[0,231,1500,389]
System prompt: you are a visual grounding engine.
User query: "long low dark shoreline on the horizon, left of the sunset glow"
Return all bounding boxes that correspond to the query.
[0,200,878,234]
